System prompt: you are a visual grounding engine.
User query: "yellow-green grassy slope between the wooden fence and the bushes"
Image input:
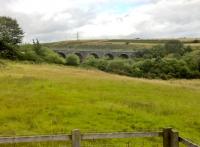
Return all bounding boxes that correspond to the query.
[0,62,200,142]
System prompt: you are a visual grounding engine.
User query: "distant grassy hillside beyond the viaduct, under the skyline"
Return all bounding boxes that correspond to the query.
[44,39,200,50]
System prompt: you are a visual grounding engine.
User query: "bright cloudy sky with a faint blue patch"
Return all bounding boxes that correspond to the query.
[0,0,200,42]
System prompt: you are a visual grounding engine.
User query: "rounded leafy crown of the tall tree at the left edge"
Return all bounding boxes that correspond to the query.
[0,16,24,45]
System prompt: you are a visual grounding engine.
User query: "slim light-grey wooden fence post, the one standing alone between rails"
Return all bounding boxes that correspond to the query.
[72,129,81,147]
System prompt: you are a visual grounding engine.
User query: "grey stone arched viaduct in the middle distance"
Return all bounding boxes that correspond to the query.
[54,49,143,61]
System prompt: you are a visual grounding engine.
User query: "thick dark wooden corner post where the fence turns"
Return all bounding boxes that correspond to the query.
[163,128,179,147]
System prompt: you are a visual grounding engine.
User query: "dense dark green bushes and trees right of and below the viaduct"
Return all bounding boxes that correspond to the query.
[81,42,200,79]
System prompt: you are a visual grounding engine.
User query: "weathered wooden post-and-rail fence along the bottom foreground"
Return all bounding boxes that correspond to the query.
[0,128,200,147]
